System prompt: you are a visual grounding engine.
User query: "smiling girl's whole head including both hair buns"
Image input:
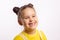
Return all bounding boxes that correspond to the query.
[13,3,38,30]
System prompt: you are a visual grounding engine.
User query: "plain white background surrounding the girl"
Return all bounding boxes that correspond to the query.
[0,0,60,40]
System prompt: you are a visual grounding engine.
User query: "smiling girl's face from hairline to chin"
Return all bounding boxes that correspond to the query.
[21,7,38,30]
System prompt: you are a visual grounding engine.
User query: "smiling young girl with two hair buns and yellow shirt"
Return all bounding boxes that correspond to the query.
[13,3,47,40]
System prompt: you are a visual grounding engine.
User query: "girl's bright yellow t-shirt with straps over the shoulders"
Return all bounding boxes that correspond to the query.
[14,30,47,40]
